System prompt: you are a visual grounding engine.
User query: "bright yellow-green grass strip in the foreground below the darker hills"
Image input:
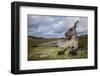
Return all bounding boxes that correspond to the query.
[28,47,87,61]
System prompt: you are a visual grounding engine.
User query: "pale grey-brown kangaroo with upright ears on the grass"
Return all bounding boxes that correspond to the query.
[40,20,79,55]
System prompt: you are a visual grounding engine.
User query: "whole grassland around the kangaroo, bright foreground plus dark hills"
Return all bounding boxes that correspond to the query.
[28,36,88,61]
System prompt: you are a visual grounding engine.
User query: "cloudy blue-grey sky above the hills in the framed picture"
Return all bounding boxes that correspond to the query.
[27,14,88,38]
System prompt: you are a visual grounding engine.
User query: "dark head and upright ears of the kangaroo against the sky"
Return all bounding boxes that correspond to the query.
[65,20,79,39]
